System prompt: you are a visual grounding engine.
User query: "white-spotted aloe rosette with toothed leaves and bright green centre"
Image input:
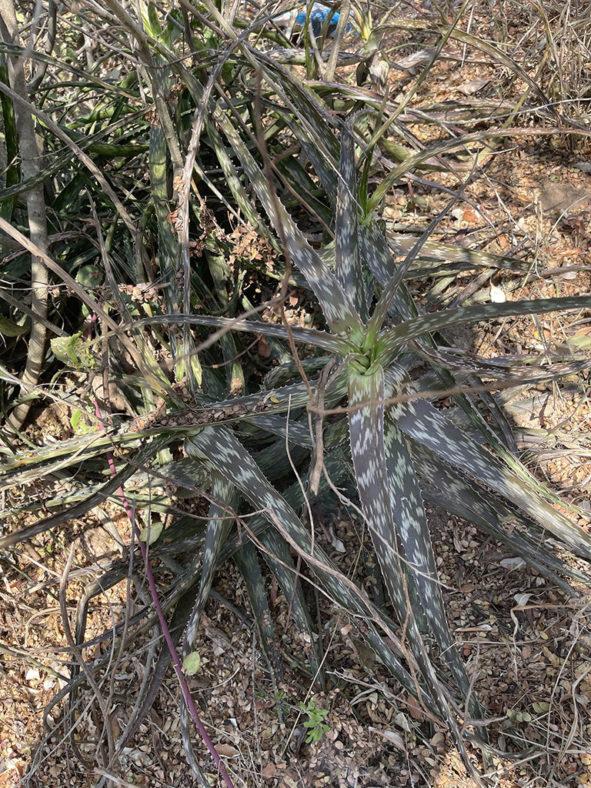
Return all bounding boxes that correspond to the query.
[175,117,591,776]
